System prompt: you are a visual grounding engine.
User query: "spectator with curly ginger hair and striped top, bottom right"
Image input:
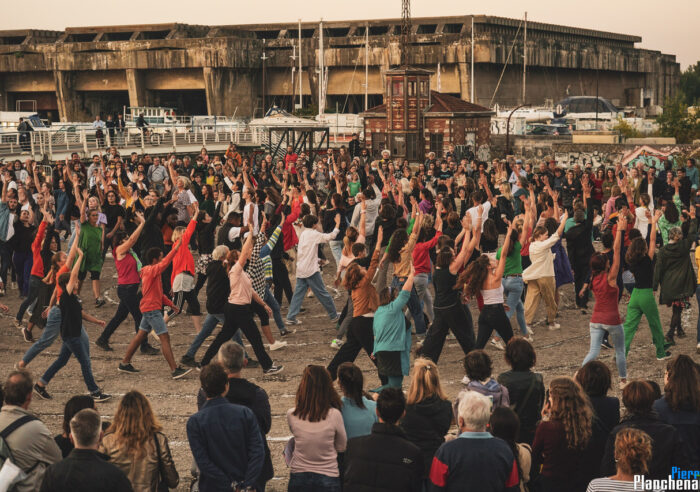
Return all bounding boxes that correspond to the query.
[586,427,652,492]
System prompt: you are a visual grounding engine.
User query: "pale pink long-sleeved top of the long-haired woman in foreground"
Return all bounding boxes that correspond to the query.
[287,408,348,477]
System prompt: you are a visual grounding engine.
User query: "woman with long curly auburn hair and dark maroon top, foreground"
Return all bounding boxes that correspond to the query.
[532,377,594,492]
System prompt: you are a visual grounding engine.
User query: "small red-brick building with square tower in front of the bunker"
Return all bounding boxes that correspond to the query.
[362,67,494,162]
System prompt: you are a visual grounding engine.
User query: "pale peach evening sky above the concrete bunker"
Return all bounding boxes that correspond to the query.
[0,0,700,70]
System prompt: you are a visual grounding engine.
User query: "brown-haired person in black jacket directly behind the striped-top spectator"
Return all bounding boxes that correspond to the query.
[600,381,697,480]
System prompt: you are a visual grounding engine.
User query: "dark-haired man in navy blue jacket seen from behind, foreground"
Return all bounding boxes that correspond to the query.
[187,364,265,492]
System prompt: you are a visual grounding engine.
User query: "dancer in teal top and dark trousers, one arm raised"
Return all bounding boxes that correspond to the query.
[372,267,416,393]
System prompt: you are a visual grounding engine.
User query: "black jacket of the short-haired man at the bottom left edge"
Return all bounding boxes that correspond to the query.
[39,449,133,492]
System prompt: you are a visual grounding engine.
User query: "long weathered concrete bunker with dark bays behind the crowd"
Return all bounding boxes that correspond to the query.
[0,15,680,121]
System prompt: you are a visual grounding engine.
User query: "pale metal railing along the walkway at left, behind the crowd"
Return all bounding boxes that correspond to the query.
[0,125,260,161]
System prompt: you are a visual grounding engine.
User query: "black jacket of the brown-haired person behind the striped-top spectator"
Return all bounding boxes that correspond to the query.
[600,413,697,480]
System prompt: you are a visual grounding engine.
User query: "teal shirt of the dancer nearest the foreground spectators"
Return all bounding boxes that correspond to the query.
[373,290,411,376]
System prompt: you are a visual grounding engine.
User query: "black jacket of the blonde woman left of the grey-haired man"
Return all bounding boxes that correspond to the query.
[399,396,452,477]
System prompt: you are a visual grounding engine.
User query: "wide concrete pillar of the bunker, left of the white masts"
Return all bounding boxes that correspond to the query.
[202,67,258,117]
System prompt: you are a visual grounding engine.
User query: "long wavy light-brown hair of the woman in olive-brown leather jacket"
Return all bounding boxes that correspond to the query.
[107,391,163,458]
